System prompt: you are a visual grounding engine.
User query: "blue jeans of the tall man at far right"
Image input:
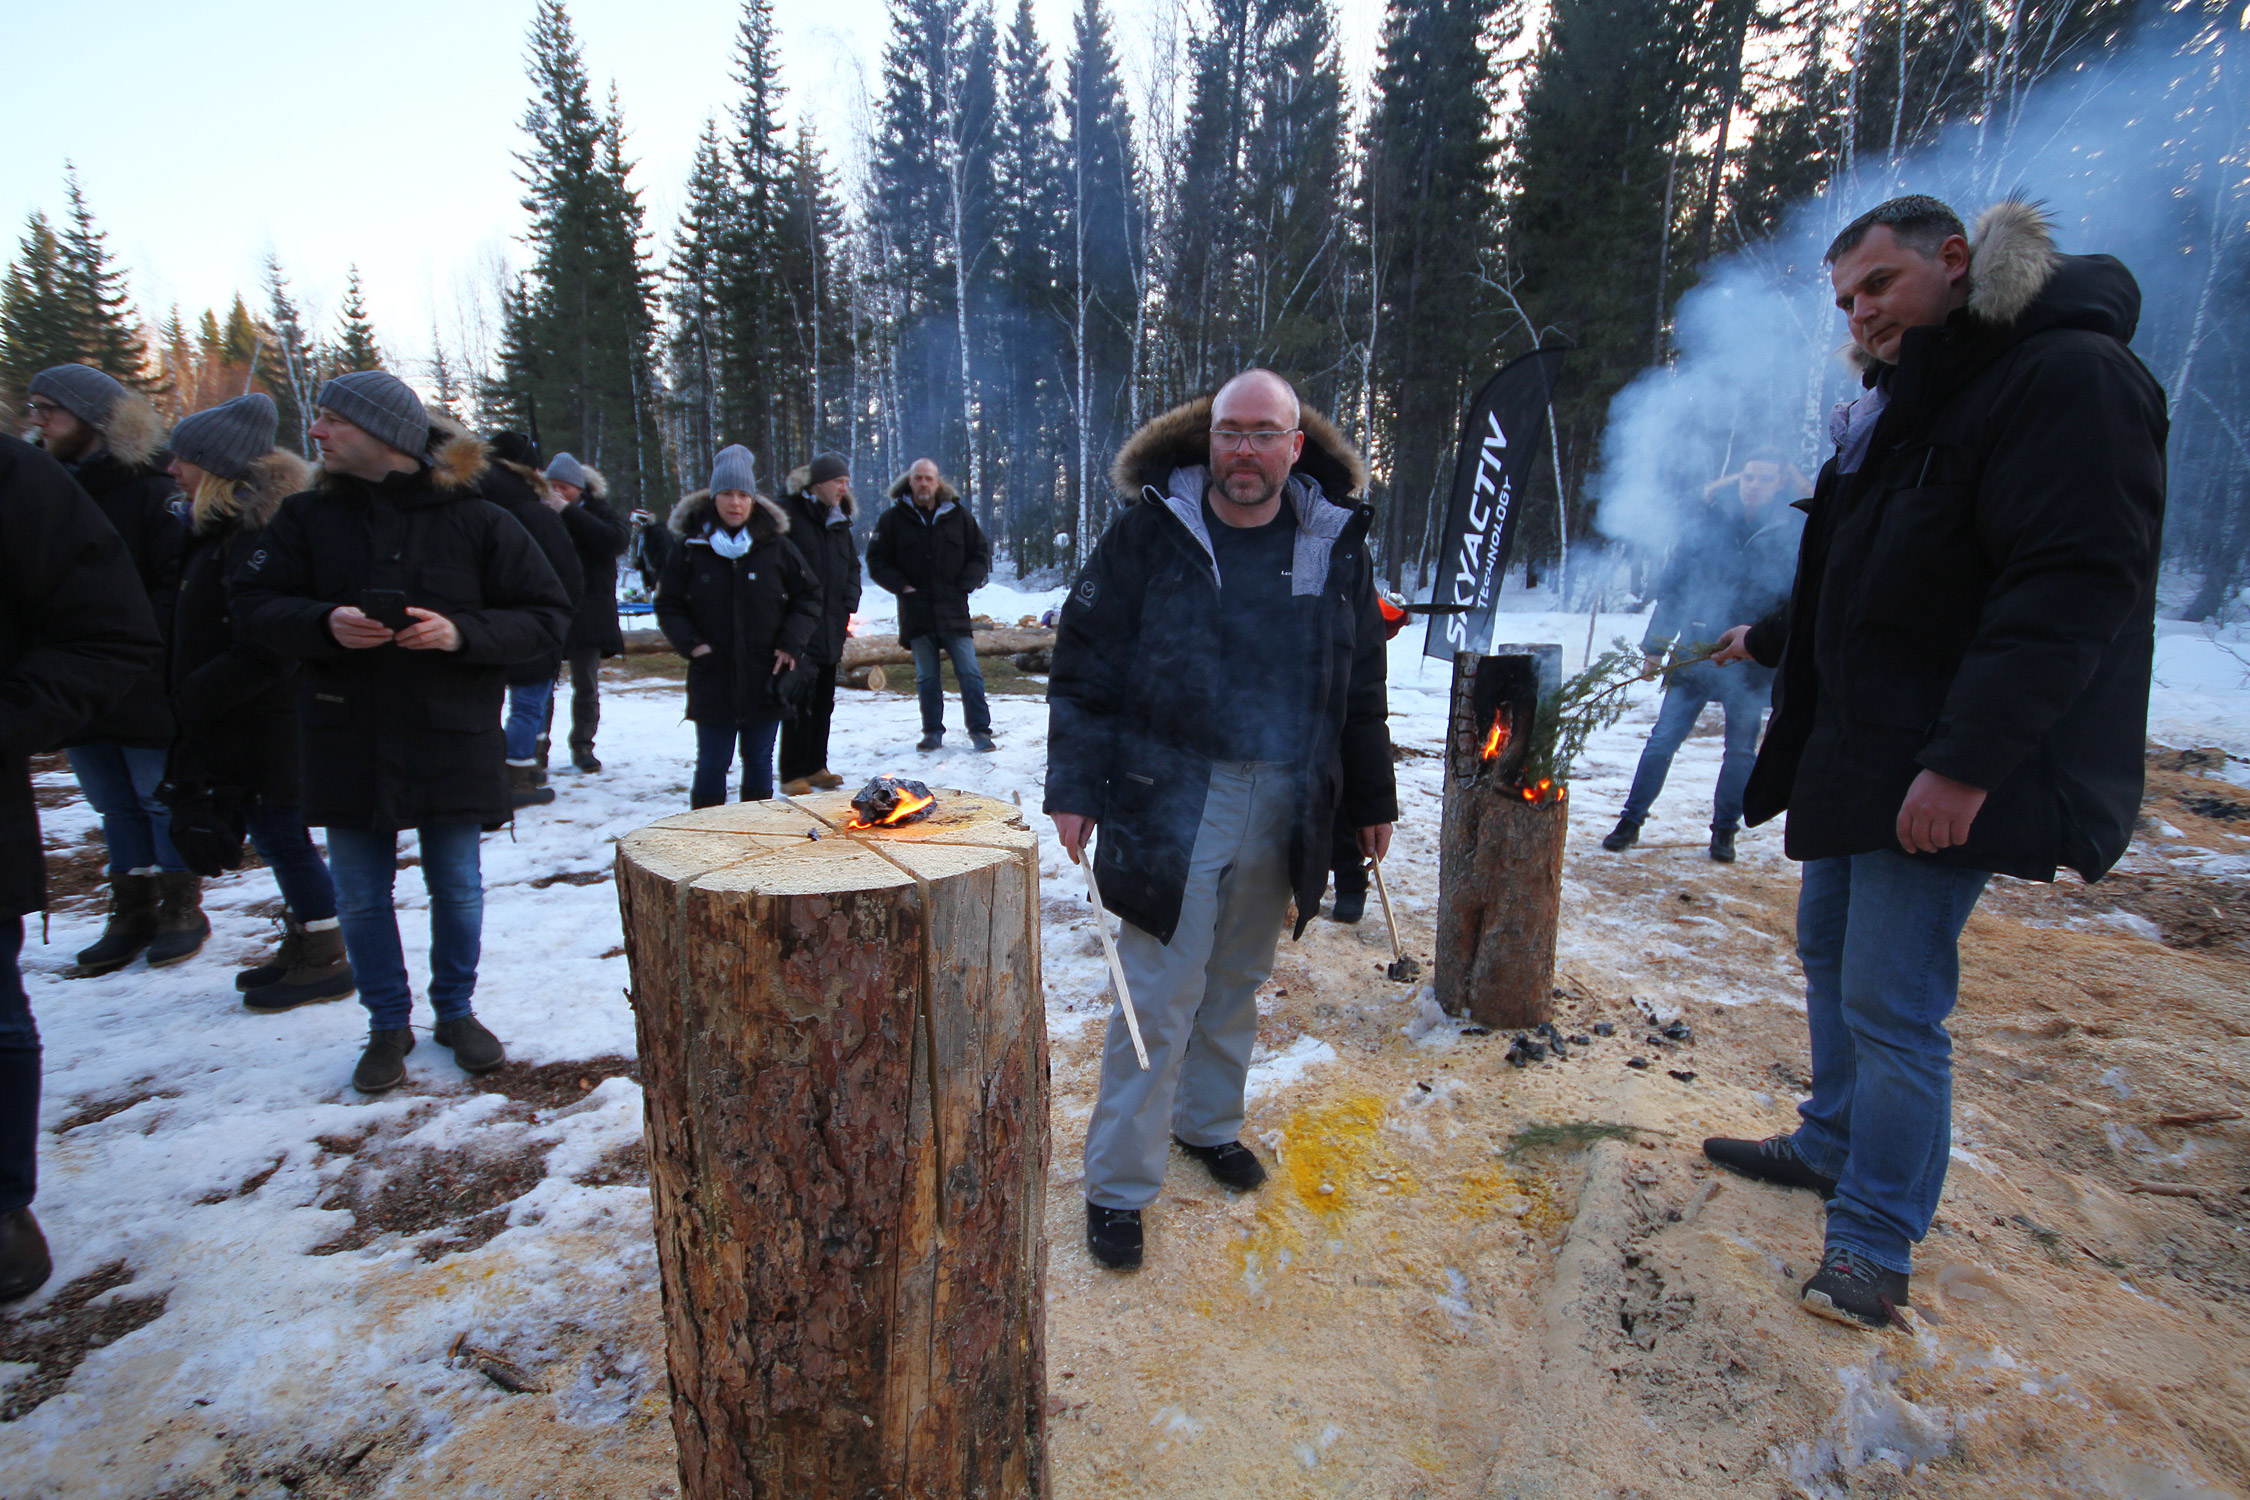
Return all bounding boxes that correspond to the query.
[1791,850,1991,1273]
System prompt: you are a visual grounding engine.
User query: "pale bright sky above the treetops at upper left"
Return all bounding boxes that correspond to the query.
[0,0,1382,375]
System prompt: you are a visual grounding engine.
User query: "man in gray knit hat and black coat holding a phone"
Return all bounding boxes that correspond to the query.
[234,371,569,1093]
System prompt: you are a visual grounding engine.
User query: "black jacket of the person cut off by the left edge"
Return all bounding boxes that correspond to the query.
[0,434,164,918]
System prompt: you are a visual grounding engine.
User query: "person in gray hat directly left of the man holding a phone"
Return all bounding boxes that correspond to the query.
[169,391,353,1010]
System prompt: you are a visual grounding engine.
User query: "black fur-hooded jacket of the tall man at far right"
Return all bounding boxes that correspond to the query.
[1748,202,2167,879]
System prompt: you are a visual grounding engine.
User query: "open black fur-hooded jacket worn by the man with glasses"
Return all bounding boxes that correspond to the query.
[1046,398,1397,942]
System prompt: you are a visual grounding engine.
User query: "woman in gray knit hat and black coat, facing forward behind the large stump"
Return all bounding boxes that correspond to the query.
[657,443,821,807]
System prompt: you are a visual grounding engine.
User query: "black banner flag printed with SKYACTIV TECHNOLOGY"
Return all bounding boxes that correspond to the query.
[1422,349,1564,661]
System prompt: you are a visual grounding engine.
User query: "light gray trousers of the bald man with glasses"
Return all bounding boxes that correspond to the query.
[1087,762,1301,1208]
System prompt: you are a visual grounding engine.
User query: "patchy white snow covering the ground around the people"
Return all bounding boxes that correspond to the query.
[0,585,2250,1498]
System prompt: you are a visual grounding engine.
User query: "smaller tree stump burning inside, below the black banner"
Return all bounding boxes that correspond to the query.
[1436,645,1568,1028]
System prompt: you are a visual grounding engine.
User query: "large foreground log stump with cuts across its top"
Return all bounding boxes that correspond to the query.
[617,792,1049,1500]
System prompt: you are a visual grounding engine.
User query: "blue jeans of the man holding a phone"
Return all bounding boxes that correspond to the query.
[329,823,484,1030]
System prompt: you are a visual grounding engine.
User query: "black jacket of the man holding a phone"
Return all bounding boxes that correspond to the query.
[234,436,569,832]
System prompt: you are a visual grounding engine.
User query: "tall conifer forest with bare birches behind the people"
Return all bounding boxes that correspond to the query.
[0,0,2250,618]
